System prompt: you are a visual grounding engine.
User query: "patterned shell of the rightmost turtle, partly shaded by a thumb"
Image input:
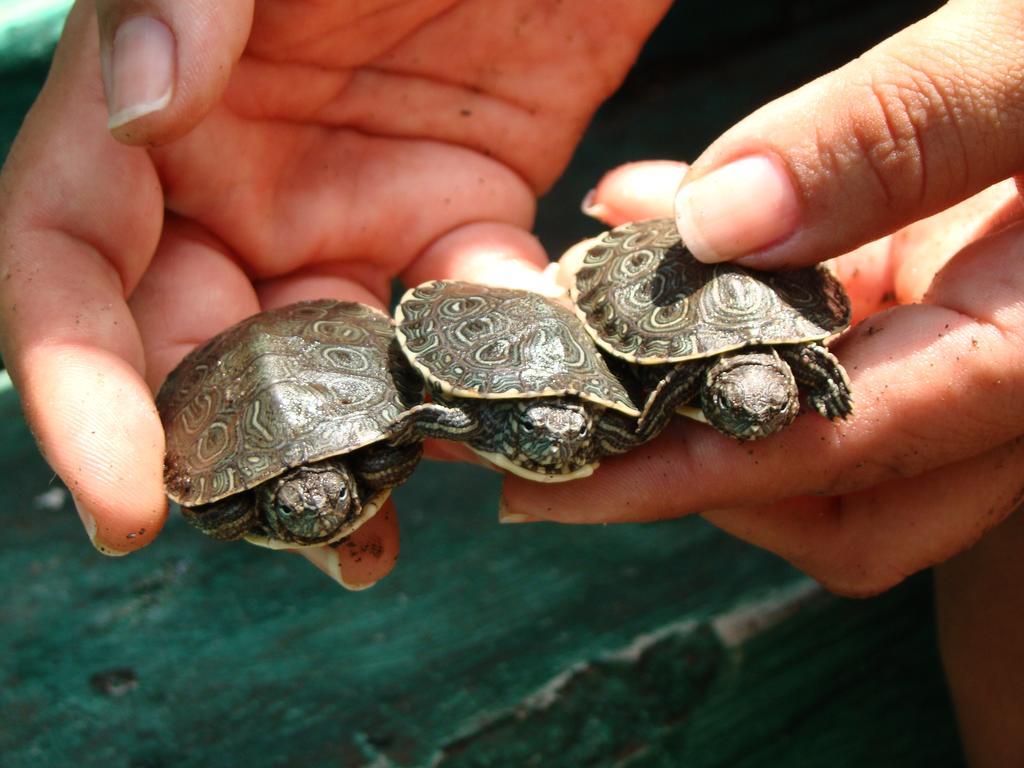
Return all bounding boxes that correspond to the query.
[572,219,850,365]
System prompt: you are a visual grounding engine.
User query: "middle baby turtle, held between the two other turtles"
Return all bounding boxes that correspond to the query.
[396,281,639,482]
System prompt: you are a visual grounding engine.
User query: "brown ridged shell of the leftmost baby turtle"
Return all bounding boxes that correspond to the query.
[157,300,415,506]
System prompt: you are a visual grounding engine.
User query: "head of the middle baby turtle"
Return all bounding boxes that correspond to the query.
[515,397,594,471]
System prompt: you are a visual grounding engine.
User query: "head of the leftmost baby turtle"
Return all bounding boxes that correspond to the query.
[258,461,360,546]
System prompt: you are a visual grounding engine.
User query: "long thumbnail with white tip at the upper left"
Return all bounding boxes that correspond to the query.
[103,16,176,130]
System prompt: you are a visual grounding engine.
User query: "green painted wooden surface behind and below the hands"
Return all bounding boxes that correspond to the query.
[0,0,963,768]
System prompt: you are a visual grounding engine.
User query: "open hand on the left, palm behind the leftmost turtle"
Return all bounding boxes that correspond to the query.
[0,0,669,586]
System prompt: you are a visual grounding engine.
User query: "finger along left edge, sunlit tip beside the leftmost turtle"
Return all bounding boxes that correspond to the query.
[0,4,166,554]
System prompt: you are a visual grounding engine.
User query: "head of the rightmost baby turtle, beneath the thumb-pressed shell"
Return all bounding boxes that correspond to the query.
[700,352,800,440]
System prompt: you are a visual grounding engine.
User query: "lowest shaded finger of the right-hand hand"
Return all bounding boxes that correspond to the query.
[703,438,1024,596]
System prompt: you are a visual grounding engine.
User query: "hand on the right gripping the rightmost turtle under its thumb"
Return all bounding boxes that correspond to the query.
[503,0,1024,595]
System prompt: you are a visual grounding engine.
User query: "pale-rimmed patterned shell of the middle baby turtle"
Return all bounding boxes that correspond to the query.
[395,281,639,416]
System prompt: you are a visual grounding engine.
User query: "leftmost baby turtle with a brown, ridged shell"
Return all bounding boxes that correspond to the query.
[157,300,422,548]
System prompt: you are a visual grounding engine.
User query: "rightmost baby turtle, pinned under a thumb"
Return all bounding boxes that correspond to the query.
[572,219,853,440]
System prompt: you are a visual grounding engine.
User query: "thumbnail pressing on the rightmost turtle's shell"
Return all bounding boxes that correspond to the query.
[676,155,800,262]
